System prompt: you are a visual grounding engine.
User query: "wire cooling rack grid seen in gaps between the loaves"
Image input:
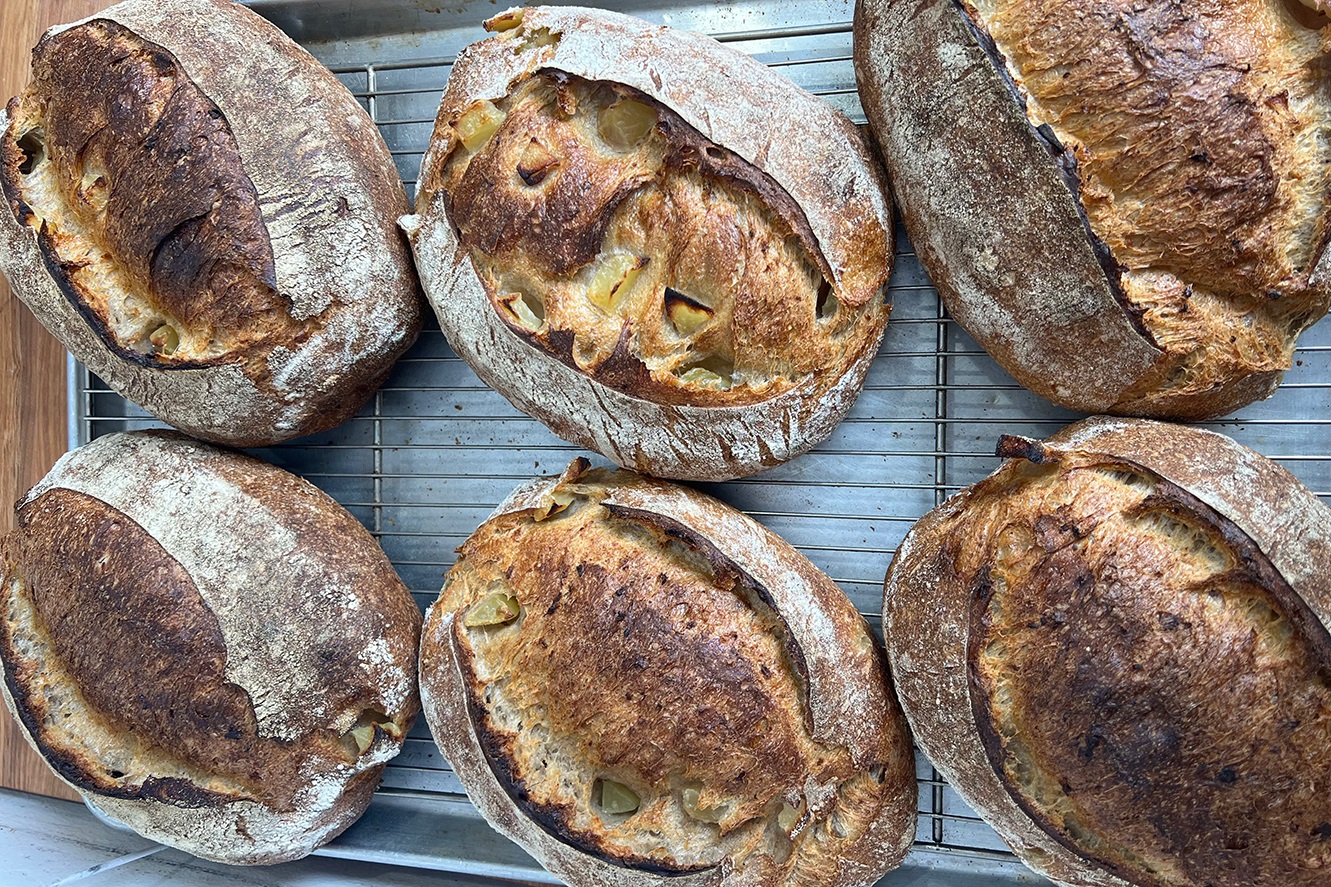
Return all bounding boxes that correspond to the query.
[72,5,1331,867]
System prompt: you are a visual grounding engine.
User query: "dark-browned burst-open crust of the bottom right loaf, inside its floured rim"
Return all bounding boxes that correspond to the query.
[944,451,1331,887]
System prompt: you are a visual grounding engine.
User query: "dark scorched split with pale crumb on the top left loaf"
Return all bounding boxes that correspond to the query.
[0,19,296,369]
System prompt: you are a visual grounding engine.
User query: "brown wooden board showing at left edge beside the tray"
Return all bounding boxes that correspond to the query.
[0,0,110,798]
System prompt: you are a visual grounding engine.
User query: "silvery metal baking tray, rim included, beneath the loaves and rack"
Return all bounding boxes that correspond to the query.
[69,0,1331,886]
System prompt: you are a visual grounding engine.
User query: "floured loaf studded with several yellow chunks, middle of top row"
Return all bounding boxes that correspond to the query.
[402,7,892,479]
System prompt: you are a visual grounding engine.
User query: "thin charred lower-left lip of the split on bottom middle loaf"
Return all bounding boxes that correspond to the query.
[450,621,712,875]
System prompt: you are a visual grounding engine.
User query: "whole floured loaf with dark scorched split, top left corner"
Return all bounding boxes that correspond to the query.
[0,0,423,446]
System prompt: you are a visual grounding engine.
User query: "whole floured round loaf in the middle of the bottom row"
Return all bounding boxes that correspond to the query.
[421,459,916,887]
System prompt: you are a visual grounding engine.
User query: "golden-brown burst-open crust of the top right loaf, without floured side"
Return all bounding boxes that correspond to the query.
[958,0,1331,418]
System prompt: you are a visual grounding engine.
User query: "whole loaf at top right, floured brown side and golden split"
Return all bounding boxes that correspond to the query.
[855,0,1331,420]
